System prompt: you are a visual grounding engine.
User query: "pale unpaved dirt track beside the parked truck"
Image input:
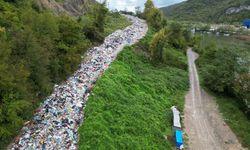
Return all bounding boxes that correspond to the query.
[184,49,243,150]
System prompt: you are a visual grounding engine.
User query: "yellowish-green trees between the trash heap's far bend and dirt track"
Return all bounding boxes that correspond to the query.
[139,0,196,69]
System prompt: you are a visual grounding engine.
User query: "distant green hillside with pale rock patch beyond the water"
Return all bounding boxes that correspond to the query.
[161,0,250,23]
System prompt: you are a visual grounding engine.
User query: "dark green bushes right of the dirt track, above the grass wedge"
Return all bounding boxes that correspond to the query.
[198,35,250,113]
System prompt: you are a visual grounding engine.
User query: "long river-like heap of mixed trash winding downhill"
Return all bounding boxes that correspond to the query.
[10,16,147,150]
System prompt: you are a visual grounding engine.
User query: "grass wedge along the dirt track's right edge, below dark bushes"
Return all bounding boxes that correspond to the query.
[215,95,250,149]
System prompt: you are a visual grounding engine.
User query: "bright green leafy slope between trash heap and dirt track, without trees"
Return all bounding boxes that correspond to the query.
[79,47,188,150]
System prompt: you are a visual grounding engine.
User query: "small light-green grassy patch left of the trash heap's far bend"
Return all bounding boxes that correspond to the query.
[104,13,131,36]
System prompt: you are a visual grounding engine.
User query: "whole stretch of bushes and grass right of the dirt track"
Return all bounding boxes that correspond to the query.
[196,35,250,148]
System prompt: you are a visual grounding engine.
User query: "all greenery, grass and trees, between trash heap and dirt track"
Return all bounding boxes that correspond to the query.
[79,0,193,149]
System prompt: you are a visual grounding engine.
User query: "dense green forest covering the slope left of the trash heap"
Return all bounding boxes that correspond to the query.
[0,0,129,148]
